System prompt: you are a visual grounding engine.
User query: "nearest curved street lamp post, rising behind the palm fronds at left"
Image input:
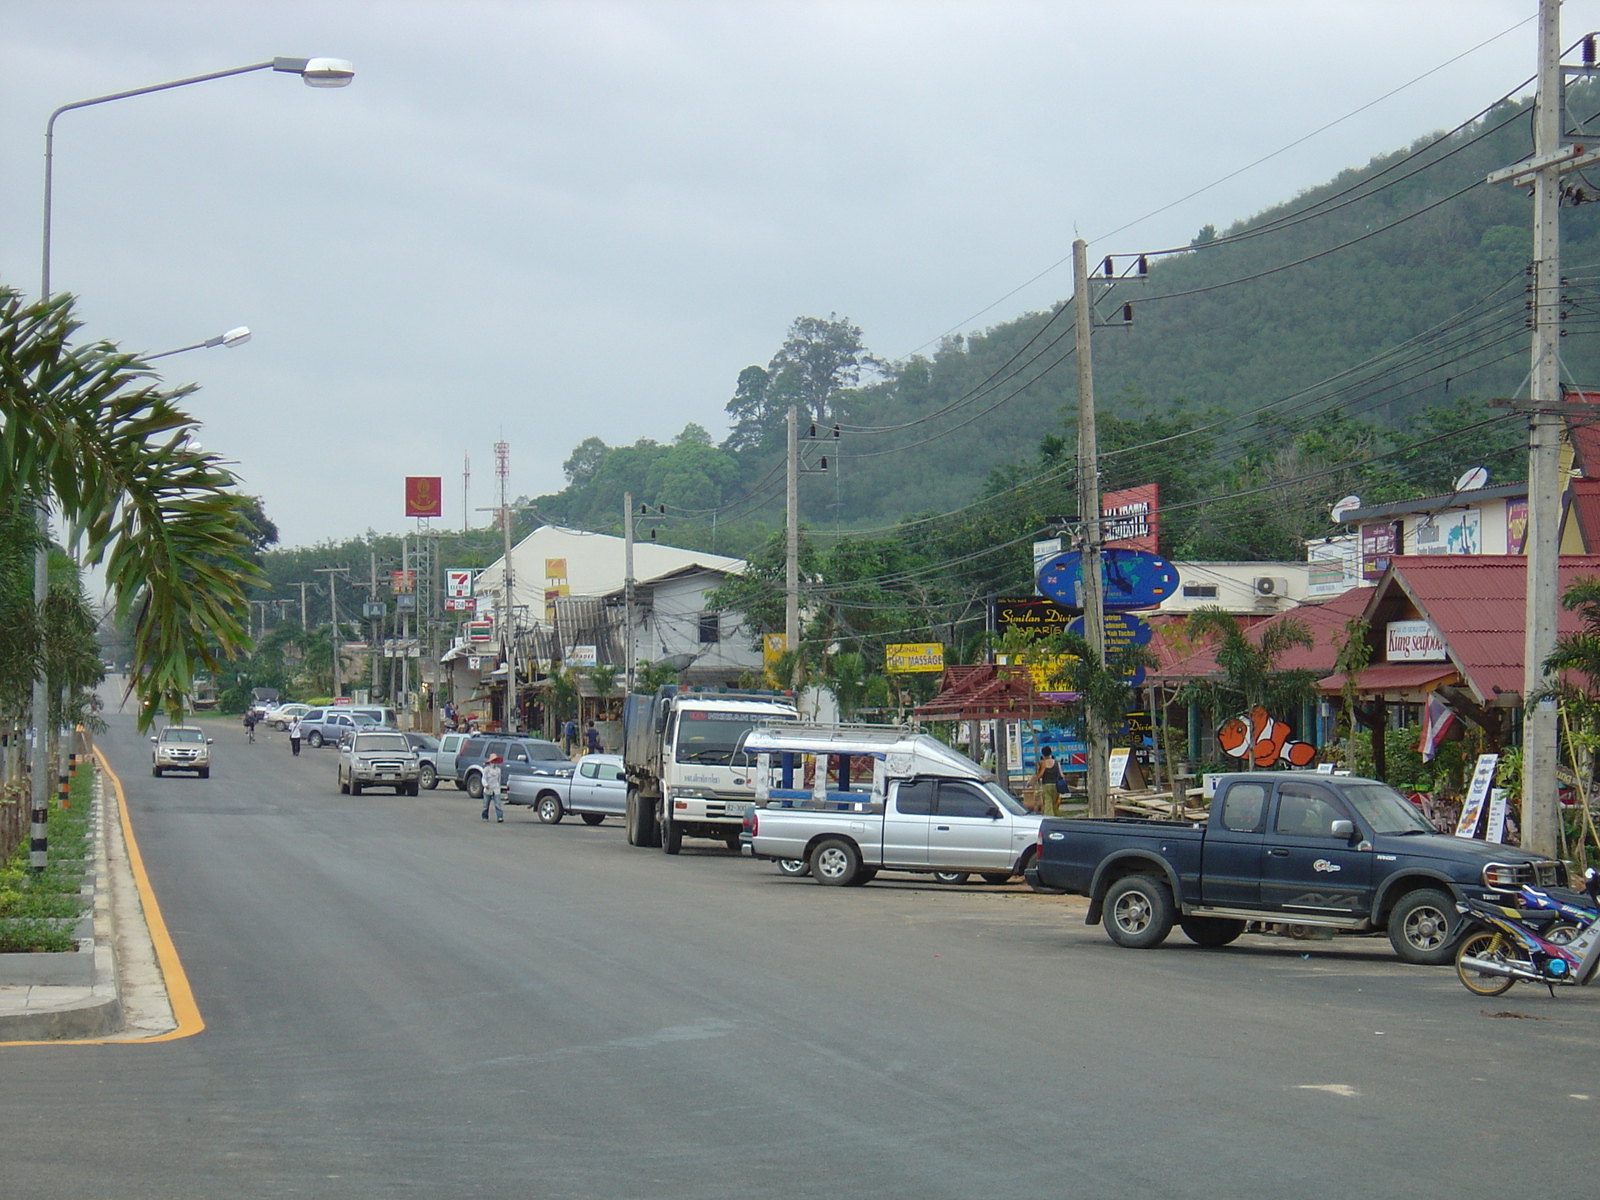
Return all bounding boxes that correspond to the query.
[29,58,355,870]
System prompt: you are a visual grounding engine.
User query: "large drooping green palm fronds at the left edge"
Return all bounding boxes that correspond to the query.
[0,286,258,723]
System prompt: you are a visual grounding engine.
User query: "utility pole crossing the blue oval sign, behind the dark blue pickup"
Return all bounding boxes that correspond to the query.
[1075,238,1110,816]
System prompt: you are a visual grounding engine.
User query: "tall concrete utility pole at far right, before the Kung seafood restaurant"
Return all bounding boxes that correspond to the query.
[1488,0,1600,858]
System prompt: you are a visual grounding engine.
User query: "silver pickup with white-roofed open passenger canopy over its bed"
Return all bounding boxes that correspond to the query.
[741,725,1042,886]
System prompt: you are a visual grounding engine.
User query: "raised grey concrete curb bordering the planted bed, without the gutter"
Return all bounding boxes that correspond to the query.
[0,763,123,1042]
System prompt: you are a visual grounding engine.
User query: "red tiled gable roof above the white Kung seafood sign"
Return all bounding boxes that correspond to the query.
[1374,554,1600,704]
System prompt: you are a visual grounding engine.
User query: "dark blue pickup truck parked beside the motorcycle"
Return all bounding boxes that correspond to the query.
[1027,771,1566,963]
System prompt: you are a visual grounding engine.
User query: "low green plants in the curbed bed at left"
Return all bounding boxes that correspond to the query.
[0,763,94,954]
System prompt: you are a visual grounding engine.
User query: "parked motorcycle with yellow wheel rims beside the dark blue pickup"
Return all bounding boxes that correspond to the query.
[1456,867,1600,997]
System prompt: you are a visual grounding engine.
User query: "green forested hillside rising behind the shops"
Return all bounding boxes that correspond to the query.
[538,86,1600,552]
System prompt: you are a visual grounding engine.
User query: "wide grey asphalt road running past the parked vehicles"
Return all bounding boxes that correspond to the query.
[0,718,1600,1200]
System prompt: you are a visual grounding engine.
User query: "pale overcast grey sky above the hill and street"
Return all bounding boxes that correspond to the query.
[0,0,1580,544]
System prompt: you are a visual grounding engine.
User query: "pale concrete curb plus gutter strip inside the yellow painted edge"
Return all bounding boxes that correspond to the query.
[0,760,178,1043]
